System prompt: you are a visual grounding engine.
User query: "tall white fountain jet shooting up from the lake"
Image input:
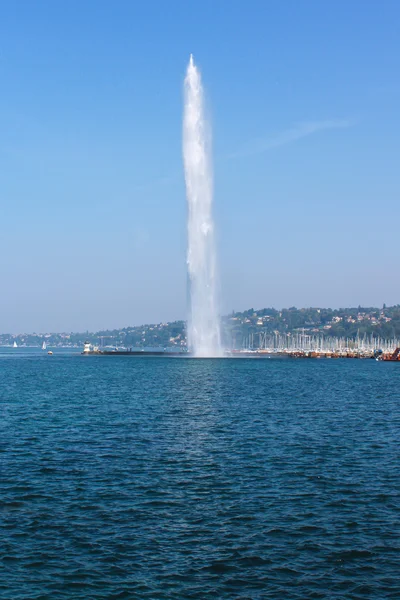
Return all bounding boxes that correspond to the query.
[183,55,222,357]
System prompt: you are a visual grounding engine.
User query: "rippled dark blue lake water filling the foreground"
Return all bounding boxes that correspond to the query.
[0,349,400,600]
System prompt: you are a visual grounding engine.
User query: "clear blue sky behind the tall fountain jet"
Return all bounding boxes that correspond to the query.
[0,0,400,332]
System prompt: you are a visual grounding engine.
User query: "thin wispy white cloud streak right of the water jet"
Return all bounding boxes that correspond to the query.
[229,119,354,158]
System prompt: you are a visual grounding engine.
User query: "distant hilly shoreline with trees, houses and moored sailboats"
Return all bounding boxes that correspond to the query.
[0,304,400,350]
